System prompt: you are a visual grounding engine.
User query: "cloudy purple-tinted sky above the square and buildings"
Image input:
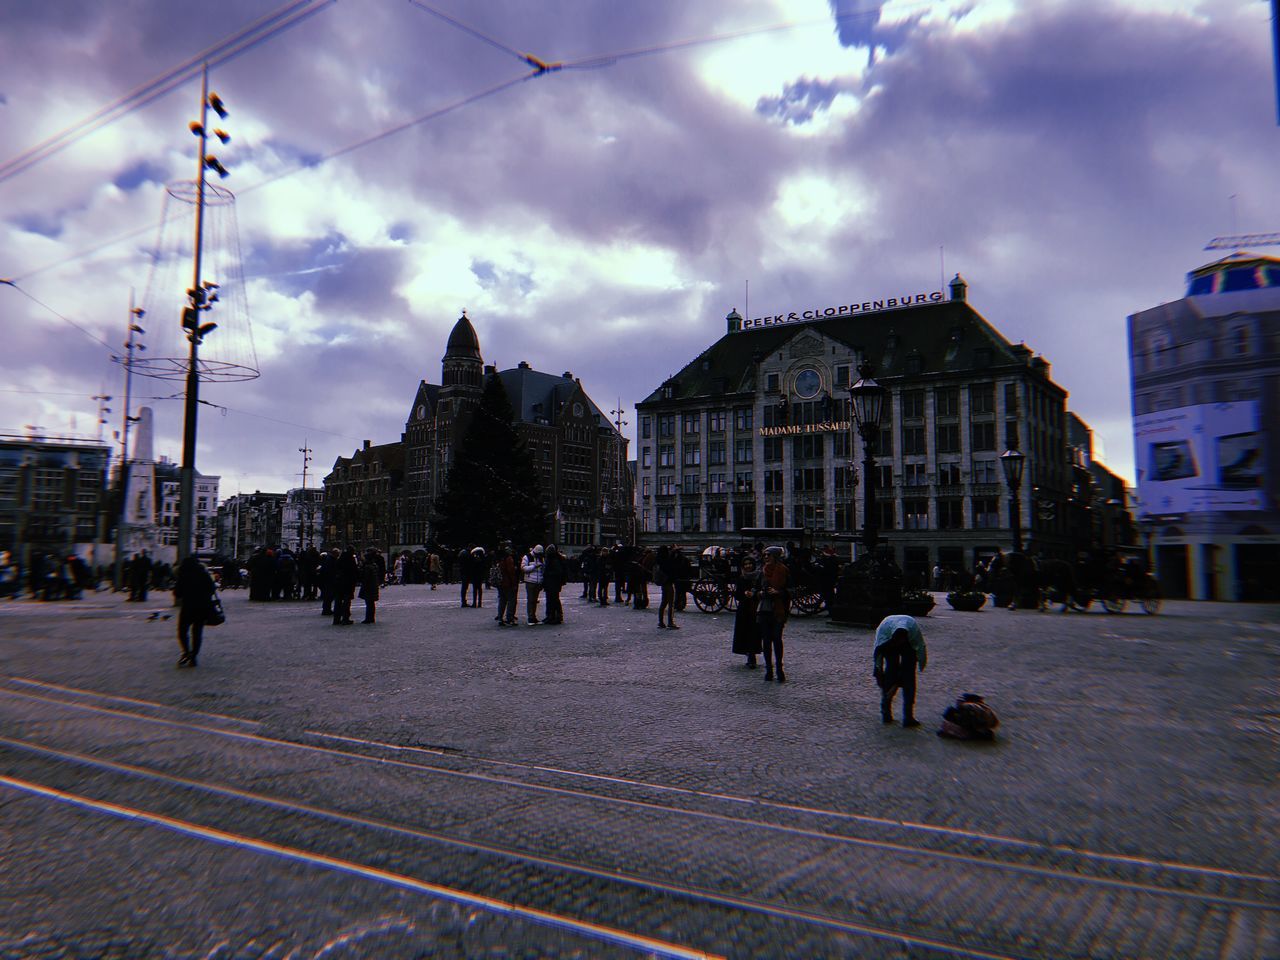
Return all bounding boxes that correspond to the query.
[0,0,1280,495]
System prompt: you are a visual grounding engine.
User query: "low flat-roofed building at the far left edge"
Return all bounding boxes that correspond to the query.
[0,436,111,570]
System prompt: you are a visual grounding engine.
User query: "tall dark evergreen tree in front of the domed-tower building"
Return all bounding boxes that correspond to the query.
[435,375,547,547]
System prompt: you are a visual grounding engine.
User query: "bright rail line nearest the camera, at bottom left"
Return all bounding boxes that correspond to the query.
[0,776,721,960]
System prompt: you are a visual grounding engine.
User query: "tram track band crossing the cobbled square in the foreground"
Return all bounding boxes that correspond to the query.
[0,677,1280,957]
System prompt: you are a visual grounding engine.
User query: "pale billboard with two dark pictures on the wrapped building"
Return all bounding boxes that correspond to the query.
[1133,401,1266,516]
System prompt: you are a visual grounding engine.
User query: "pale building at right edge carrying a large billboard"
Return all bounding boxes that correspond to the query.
[1129,252,1280,600]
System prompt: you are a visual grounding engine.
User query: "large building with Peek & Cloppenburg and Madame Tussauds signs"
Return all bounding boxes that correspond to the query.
[636,275,1111,577]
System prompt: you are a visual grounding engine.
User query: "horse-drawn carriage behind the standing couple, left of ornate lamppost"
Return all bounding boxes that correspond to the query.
[690,527,827,617]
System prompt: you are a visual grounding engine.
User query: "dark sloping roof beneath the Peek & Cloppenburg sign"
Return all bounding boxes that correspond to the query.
[643,300,1049,403]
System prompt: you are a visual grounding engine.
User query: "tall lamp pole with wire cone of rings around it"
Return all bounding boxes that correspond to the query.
[133,64,259,562]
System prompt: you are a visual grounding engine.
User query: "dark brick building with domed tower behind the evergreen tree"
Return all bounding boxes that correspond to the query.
[324,312,634,552]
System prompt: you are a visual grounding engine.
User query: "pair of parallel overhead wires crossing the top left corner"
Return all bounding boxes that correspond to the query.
[0,0,337,183]
